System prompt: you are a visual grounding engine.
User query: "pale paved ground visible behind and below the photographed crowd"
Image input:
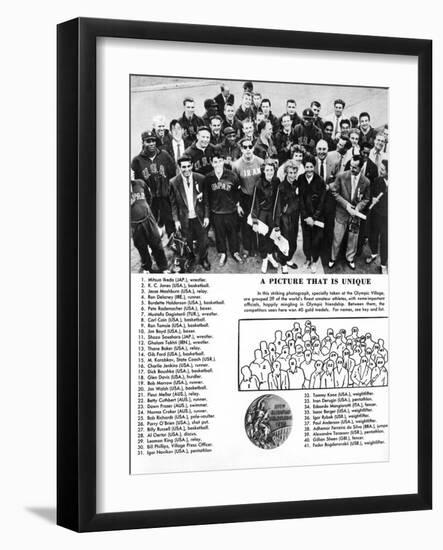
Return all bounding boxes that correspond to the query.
[130,76,388,273]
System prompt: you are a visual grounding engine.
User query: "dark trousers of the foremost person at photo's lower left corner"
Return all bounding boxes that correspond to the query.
[132,216,168,271]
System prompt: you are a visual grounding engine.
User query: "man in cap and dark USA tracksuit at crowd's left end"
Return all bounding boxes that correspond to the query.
[131,131,176,236]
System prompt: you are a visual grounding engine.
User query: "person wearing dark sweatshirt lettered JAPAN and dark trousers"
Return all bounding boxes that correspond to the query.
[203,149,243,266]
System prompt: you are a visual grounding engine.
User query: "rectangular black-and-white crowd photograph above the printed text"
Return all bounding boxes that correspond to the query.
[130,75,389,275]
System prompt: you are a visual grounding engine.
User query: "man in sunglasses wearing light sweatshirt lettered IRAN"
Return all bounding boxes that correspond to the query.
[232,137,263,257]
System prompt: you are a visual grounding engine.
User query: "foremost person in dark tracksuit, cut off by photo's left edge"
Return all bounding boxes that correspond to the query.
[130,179,168,272]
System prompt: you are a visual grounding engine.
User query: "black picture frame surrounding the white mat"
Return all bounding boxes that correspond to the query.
[57,18,432,531]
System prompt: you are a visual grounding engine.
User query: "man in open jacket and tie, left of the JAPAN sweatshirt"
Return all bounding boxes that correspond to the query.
[170,156,211,271]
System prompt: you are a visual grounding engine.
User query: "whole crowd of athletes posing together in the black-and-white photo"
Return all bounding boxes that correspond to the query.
[130,82,389,273]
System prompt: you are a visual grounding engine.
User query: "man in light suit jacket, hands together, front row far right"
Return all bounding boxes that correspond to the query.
[328,157,370,270]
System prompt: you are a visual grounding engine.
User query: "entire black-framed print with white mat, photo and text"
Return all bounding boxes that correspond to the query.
[57,18,432,531]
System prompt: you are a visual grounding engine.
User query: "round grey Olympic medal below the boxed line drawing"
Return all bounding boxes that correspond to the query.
[245,394,292,449]
